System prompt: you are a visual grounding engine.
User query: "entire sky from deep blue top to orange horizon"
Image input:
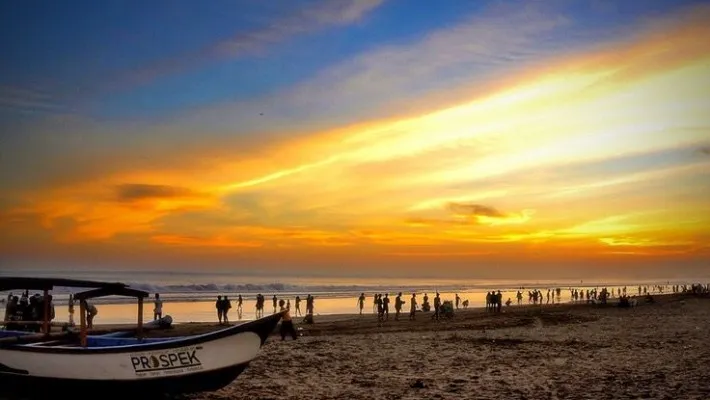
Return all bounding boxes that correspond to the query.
[0,0,710,279]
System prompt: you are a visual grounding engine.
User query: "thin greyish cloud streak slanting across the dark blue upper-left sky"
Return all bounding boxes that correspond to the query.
[0,0,385,114]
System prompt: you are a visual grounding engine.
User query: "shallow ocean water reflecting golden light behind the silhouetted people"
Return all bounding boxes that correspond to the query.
[0,271,692,324]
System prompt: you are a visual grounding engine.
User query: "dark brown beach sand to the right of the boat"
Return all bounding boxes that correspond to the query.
[163,295,710,400]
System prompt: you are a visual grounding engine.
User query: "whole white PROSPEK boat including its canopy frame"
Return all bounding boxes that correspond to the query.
[0,278,281,395]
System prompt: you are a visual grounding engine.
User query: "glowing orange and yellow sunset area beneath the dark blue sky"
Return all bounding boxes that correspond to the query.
[0,2,710,274]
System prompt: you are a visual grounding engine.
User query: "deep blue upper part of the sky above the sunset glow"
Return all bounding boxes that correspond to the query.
[0,0,700,124]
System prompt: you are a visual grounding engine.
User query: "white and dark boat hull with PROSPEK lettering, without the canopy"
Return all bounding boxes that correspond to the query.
[0,314,281,395]
